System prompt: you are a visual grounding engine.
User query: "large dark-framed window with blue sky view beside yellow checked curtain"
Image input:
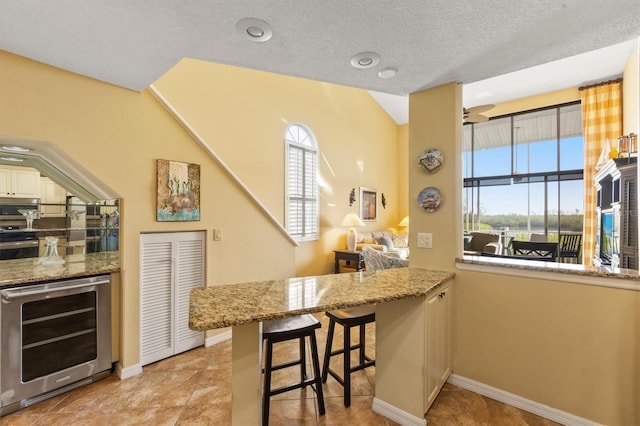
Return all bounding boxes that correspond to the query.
[463,103,584,241]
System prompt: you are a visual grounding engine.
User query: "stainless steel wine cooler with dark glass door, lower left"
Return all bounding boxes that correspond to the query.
[0,275,111,416]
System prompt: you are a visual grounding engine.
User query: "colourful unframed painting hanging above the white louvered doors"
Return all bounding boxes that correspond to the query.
[156,160,200,222]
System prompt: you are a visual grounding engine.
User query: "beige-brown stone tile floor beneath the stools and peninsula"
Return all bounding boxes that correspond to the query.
[0,315,556,426]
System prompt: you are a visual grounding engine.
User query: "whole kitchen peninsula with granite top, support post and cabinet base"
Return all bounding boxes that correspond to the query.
[189,267,454,425]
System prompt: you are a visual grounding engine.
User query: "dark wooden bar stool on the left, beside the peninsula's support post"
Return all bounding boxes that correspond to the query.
[262,314,325,426]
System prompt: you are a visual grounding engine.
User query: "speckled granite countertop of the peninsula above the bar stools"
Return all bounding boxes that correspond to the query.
[189,267,455,330]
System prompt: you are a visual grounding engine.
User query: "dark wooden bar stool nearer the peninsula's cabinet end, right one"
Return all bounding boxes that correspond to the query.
[322,306,376,407]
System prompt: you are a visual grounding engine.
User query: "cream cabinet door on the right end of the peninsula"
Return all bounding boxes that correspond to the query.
[425,283,453,411]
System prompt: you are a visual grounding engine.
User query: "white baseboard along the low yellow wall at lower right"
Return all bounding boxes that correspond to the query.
[447,374,601,426]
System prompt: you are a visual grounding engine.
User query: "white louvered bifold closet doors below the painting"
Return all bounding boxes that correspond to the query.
[140,231,205,365]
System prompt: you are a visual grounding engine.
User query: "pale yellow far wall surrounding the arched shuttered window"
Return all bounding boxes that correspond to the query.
[154,59,407,276]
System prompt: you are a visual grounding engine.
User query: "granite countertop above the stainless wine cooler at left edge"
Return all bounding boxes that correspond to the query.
[0,251,120,288]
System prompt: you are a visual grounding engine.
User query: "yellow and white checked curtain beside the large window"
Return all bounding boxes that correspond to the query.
[580,81,622,265]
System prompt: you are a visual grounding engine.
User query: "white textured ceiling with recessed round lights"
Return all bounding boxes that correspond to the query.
[0,0,640,115]
